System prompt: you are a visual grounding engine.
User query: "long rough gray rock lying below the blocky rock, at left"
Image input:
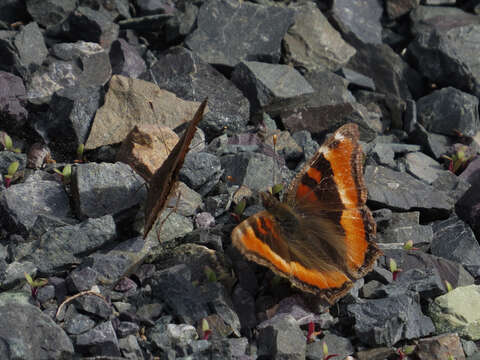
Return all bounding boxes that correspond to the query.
[18,215,116,274]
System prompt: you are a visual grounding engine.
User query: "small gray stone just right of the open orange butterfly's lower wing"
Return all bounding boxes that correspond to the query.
[377,211,433,244]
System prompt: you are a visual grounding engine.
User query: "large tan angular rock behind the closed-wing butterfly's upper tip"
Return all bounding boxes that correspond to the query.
[85,75,200,149]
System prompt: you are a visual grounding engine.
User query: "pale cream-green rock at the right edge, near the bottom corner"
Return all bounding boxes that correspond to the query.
[429,285,480,341]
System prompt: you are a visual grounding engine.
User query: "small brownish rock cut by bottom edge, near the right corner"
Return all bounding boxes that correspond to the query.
[415,334,465,360]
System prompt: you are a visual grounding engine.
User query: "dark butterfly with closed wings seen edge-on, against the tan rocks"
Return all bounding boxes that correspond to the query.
[143,99,207,238]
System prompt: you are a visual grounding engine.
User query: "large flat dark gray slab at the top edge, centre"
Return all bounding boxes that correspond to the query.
[185,0,294,66]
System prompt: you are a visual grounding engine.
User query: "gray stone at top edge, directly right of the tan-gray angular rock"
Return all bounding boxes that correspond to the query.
[331,0,383,44]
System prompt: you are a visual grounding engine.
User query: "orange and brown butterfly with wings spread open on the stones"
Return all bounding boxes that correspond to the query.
[231,123,382,304]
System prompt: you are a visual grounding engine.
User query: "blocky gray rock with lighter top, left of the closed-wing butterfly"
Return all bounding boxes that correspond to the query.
[72,162,146,218]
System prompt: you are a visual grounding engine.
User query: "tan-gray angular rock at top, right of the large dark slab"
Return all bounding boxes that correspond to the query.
[283,2,355,71]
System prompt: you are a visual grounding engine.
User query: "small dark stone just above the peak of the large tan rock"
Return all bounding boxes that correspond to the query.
[109,39,147,79]
